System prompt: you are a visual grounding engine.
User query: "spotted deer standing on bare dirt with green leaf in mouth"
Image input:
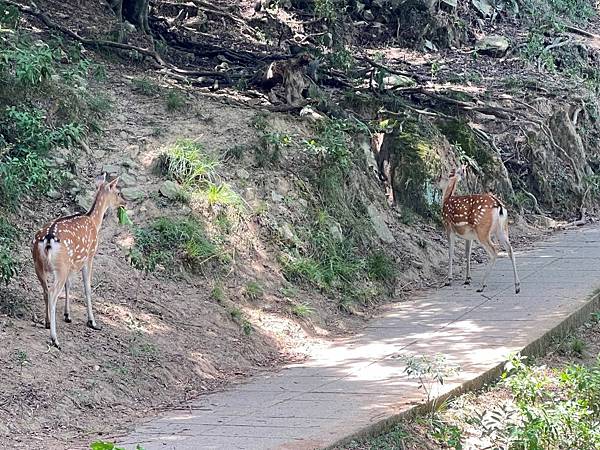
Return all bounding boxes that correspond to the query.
[31,174,125,349]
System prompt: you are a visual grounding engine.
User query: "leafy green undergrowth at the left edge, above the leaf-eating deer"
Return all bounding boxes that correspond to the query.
[0,5,112,283]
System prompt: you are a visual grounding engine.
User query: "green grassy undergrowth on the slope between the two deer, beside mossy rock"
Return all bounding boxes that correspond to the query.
[280,120,395,316]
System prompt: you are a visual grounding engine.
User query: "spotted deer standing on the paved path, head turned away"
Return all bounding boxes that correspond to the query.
[442,165,521,294]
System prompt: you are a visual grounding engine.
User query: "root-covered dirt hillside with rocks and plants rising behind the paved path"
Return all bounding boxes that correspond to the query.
[0,0,600,448]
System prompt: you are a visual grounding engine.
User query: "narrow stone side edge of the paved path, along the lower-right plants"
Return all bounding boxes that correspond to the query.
[324,289,600,450]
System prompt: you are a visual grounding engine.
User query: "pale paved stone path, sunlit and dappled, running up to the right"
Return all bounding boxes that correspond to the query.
[121,228,600,450]
